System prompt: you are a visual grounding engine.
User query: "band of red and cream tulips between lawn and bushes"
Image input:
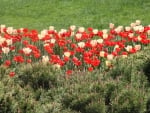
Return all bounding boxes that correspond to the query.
[0,20,150,76]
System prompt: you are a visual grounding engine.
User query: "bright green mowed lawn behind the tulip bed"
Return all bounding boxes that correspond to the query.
[0,0,150,30]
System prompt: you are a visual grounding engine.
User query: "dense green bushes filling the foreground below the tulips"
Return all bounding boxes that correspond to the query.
[0,47,150,113]
